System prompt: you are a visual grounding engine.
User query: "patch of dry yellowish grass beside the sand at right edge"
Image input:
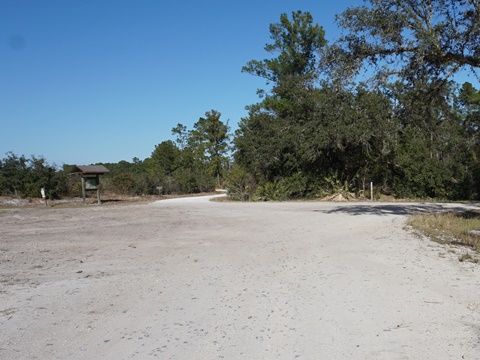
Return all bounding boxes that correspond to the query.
[407,211,480,252]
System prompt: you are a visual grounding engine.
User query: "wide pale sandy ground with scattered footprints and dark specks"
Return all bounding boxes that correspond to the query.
[0,198,480,360]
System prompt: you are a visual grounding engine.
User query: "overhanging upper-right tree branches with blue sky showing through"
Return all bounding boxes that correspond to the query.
[330,0,480,86]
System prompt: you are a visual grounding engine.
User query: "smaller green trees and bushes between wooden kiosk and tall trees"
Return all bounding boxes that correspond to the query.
[94,110,229,195]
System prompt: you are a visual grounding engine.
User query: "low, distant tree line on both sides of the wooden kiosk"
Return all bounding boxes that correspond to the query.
[0,110,230,199]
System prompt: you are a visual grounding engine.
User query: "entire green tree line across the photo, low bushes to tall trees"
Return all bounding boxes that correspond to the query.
[0,0,480,200]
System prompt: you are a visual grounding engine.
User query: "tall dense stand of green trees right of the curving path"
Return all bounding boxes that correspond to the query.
[234,9,480,200]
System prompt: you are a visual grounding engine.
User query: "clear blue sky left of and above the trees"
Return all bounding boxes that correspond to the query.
[0,0,362,166]
